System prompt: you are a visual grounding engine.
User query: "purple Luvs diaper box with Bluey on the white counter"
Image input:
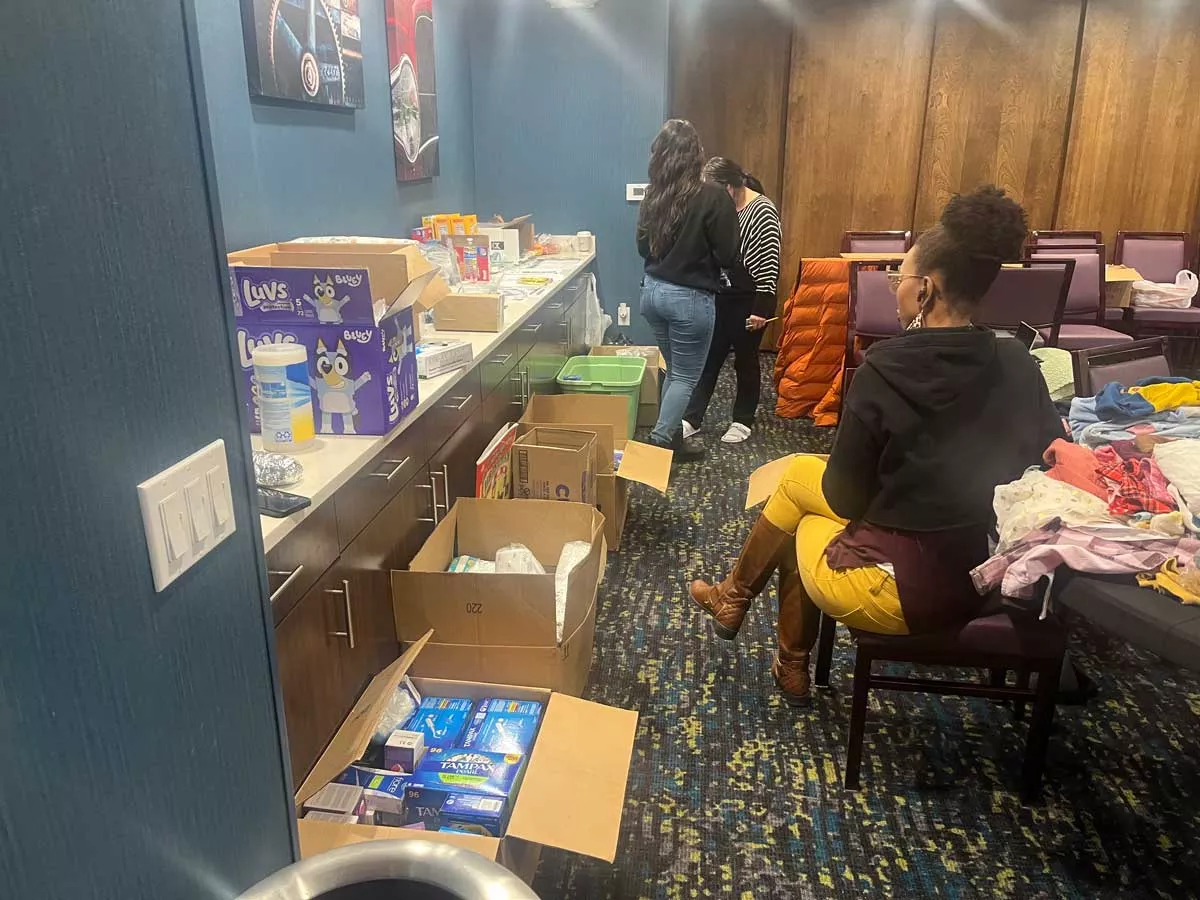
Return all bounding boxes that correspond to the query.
[229,240,448,434]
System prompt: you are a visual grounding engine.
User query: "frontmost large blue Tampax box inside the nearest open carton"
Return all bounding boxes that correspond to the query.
[404,750,526,838]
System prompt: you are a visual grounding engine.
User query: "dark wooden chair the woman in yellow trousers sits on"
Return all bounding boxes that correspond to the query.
[815,602,1067,803]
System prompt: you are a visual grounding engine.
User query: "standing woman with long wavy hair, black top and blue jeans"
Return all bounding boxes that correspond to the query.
[637,119,740,462]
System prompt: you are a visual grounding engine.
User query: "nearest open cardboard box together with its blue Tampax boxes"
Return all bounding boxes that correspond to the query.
[295,631,637,881]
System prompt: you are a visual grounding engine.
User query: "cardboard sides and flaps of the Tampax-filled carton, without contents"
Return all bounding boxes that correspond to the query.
[295,628,637,881]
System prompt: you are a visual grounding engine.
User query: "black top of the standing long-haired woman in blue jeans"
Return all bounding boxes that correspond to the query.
[637,182,742,294]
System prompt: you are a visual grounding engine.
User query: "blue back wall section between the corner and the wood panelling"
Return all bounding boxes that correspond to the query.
[470,0,667,342]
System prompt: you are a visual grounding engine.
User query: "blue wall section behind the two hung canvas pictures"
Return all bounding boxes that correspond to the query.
[196,0,476,250]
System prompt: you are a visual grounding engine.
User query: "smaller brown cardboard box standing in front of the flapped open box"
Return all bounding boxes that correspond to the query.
[512,428,596,505]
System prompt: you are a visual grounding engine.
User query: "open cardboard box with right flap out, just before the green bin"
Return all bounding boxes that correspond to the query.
[518,394,672,550]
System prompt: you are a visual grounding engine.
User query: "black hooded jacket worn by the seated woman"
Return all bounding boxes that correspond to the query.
[822,328,1066,532]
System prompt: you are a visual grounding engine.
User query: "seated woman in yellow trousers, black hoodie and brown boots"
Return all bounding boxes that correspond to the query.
[691,187,1063,706]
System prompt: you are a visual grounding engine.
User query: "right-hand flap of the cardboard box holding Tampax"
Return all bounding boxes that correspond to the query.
[508,694,637,863]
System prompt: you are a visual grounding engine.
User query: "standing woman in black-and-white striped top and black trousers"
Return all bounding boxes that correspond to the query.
[683,156,784,444]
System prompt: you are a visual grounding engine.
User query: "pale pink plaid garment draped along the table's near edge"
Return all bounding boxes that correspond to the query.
[971,520,1200,600]
